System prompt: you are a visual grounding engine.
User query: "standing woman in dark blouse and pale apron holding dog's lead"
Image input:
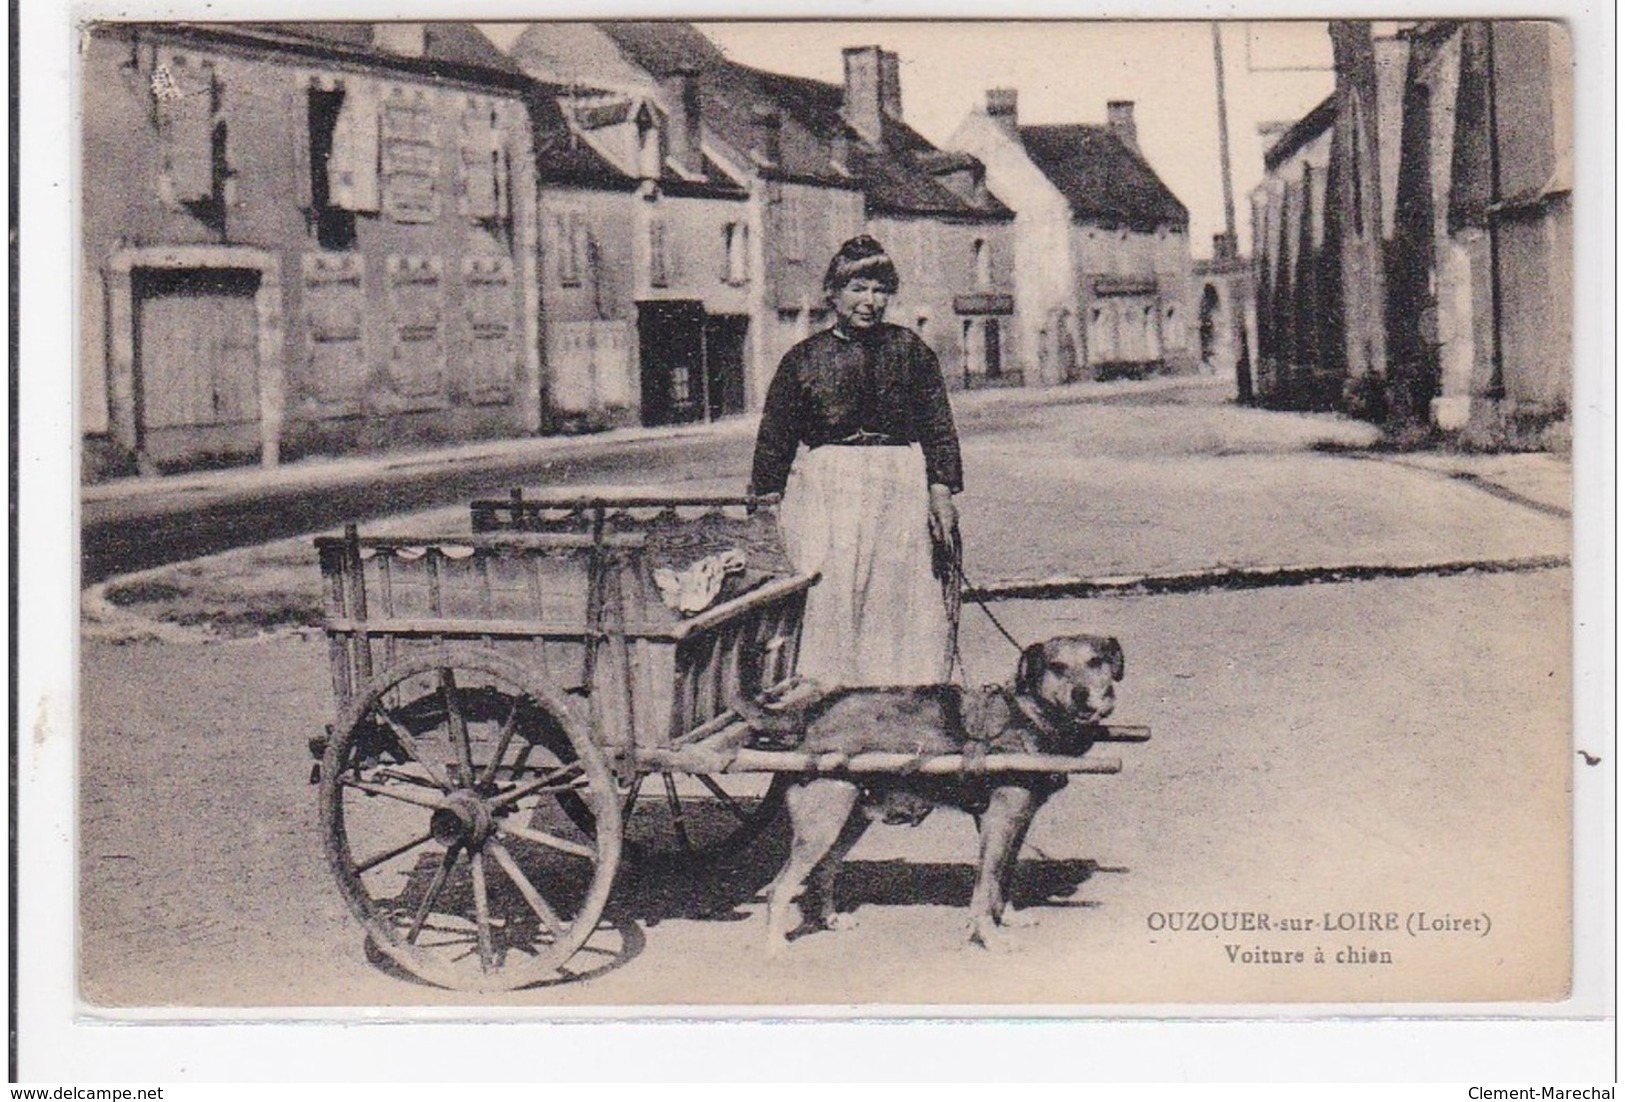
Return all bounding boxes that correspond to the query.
[751,236,964,686]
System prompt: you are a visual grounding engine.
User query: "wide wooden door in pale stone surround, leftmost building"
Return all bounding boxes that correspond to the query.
[133,268,260,462]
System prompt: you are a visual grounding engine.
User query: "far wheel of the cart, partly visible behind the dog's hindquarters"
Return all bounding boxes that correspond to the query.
[621,772,790,860]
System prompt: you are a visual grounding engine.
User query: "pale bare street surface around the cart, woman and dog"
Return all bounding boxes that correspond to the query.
[80,385,1575,1006]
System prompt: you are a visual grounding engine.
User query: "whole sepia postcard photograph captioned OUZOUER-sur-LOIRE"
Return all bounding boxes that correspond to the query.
[68,20,1579,1019]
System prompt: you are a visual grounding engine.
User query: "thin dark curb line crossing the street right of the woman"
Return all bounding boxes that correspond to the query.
[964,554,1570,601]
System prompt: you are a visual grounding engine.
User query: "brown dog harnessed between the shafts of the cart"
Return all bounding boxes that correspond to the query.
[735,636,1123,952]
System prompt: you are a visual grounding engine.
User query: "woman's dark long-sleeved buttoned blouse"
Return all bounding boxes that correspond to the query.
[751,323,964,494]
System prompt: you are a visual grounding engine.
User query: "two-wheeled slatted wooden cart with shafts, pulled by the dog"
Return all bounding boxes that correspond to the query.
[317,494,1137,991]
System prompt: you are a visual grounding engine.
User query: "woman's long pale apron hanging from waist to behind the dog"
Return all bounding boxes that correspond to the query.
[778,444,949,686]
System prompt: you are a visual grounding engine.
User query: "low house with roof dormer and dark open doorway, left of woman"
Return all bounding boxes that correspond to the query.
[516,75,752,431]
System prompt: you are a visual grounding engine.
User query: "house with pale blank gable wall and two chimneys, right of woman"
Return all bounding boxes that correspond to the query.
[947,88,1196,384]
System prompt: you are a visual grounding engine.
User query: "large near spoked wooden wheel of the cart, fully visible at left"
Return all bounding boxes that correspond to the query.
[320,649,621,991]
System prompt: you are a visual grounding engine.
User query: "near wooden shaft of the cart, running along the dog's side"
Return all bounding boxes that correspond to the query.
[637,744,1123,777]
